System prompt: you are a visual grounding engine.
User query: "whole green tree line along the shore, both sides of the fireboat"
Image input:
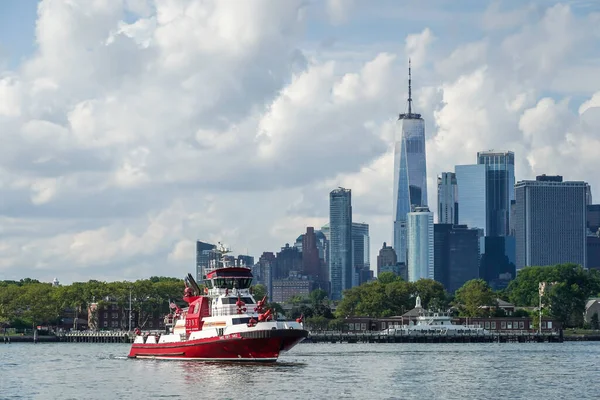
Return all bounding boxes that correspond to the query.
[0,264,600,329]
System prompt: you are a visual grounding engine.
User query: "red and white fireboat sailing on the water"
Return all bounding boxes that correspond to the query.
[128,245,308,362]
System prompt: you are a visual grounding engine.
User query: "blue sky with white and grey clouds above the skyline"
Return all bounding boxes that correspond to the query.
[0,0,600,283]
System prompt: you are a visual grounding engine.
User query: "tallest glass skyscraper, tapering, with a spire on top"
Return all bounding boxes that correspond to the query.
[394,61,427,262]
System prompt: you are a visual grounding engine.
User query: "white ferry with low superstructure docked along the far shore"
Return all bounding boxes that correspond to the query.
[381,296,490,336]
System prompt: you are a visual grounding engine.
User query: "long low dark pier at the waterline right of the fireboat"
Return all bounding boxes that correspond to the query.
[304,331,564,343]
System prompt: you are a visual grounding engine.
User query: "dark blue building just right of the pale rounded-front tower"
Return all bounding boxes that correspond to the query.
[433,224,480,293]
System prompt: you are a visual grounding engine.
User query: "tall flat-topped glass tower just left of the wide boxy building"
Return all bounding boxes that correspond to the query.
[477,150,515,236]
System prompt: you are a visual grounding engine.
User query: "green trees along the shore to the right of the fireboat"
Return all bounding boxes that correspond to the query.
[291,264,600,329]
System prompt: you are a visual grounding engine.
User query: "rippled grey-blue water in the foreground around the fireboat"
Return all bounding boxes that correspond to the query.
[0,342,600,400]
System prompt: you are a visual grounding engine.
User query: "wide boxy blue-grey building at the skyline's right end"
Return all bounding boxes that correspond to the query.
[515,175,587,270]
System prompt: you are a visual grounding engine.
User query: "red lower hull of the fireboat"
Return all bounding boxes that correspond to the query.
[129,329,308,362]
